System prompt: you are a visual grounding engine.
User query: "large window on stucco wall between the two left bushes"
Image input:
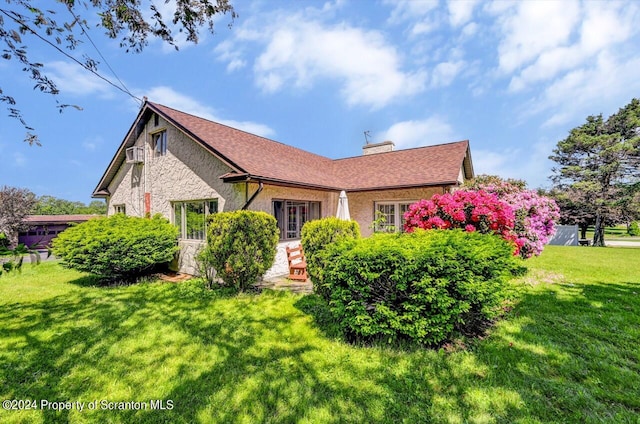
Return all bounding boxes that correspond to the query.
[173,199,218,240]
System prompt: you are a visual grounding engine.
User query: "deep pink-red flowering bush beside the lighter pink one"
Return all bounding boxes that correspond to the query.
[404,190,524,255]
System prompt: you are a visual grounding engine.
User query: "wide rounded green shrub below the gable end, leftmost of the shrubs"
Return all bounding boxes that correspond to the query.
[52,214,179,280]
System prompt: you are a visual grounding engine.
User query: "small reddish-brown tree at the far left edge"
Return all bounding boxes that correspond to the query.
[0,186,36,246]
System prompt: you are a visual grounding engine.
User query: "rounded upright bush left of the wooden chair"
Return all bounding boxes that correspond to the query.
[199,211,279,291]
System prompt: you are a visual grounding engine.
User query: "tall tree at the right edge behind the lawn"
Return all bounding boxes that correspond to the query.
[549,99,640,246]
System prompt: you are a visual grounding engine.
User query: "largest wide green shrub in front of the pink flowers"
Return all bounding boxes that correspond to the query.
[321,230,521,345]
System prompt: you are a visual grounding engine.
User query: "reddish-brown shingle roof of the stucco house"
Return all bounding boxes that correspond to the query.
[94,102,473,196]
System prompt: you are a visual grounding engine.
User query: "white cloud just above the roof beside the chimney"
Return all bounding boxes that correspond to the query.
[380,116,456,149]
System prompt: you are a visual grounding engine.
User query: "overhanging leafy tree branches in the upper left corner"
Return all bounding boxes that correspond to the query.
[0,0,237,145]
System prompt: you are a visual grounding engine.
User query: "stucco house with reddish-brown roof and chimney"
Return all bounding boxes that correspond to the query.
[93,101,473,277]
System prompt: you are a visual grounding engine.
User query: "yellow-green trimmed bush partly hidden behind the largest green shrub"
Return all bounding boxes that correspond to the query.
[301,217,360,299]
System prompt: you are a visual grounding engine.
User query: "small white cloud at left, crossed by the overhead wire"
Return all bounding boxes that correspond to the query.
[46,61,114,98]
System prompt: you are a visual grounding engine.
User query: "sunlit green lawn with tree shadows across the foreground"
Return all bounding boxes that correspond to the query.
[0,246,640,423]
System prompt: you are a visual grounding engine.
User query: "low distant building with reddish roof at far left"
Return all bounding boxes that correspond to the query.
[18,215,100,249]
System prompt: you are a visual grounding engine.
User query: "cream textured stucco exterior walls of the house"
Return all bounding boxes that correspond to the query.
[107,113,460,278]
